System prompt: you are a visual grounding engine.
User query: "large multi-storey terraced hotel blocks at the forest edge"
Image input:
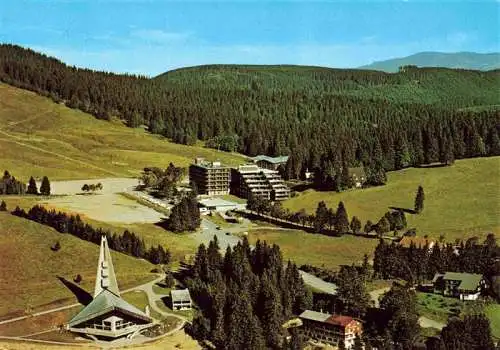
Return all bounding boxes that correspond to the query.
[189,156,290,201]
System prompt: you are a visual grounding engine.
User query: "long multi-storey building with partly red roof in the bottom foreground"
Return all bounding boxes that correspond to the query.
[299,310,363,349]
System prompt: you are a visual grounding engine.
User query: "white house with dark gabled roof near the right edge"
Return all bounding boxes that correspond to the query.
[432,272,485,300]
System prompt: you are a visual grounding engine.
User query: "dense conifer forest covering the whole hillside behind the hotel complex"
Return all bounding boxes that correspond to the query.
[0,45,500,188]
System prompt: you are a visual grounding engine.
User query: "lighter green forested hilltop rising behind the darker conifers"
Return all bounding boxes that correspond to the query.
[154,65,500,107]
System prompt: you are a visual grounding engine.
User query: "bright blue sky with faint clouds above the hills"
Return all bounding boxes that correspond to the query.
[0,0,500,76]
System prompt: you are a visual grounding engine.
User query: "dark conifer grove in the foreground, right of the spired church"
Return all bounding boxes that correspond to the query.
[183,237,312,349]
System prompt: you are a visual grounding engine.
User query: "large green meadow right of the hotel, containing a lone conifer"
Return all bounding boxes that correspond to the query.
[284,157,500,241]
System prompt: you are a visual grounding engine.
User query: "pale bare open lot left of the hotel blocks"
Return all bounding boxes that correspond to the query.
[38,178,164,224]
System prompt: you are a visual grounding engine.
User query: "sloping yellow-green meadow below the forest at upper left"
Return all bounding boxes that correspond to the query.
[0,83,244,180]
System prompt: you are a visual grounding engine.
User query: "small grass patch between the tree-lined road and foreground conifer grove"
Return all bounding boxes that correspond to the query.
[248,229,378,270]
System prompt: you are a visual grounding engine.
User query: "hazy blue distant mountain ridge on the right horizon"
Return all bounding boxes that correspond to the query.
[359,52,500,73]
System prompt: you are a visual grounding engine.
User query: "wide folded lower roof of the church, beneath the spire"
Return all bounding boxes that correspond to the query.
[69,289,151,327]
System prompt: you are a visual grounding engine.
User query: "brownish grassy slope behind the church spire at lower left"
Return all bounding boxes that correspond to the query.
[0,213,154,316]
